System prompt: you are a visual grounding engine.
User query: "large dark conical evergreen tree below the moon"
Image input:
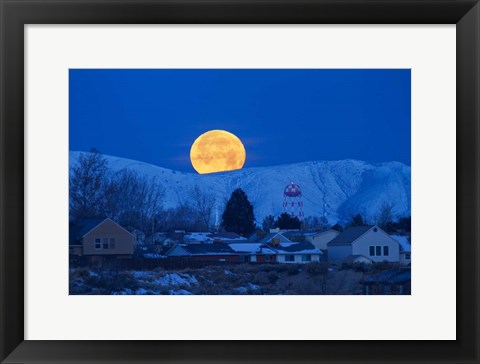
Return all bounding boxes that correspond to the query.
[222,188,255,236]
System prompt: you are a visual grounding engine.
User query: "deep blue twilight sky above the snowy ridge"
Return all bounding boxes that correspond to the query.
[69,69,411,172]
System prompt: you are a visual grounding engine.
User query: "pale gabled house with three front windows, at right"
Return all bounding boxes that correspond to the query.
[327,225,400,262]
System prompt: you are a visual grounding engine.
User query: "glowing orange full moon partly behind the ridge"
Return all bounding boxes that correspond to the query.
[190,130,246,174]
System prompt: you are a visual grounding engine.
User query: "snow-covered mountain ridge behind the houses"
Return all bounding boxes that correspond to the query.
[70,152,411,224]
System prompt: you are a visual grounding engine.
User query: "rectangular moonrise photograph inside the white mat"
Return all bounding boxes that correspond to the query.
[65,68,412,295]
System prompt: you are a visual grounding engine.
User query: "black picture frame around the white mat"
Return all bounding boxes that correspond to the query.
[0,0,480,363]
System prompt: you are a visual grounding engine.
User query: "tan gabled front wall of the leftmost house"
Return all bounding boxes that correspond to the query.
[83,220,135,255]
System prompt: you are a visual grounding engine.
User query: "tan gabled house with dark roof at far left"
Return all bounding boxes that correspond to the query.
[69,218,135,258]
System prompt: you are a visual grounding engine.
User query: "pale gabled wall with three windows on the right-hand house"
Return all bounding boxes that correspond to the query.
[352,229,400,262]
